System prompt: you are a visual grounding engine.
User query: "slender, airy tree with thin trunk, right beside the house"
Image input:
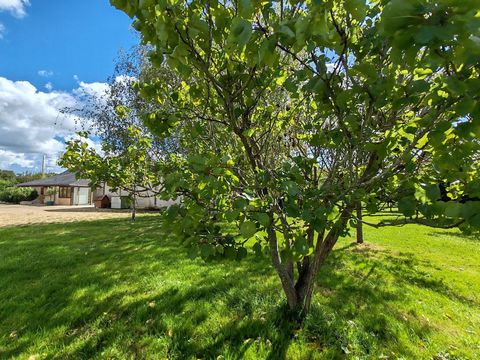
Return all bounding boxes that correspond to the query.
[59,46,179,220]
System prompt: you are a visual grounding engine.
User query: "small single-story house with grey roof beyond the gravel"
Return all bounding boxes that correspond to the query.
[17,171,93,205]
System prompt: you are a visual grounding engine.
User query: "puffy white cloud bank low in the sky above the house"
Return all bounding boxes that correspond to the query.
[0,75,107,172]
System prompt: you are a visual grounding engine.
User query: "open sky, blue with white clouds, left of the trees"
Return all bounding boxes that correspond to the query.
[0,0,138,172]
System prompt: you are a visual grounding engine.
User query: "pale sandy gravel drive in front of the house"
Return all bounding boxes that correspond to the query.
[0,204,130,227]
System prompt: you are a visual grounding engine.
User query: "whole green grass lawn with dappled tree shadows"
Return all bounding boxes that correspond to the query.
[0,216,480,359]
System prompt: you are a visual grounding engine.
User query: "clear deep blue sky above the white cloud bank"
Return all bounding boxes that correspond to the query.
[0,0,137,90]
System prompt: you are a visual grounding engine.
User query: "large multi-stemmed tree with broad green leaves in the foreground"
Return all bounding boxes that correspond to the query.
[111,0,480,314]
